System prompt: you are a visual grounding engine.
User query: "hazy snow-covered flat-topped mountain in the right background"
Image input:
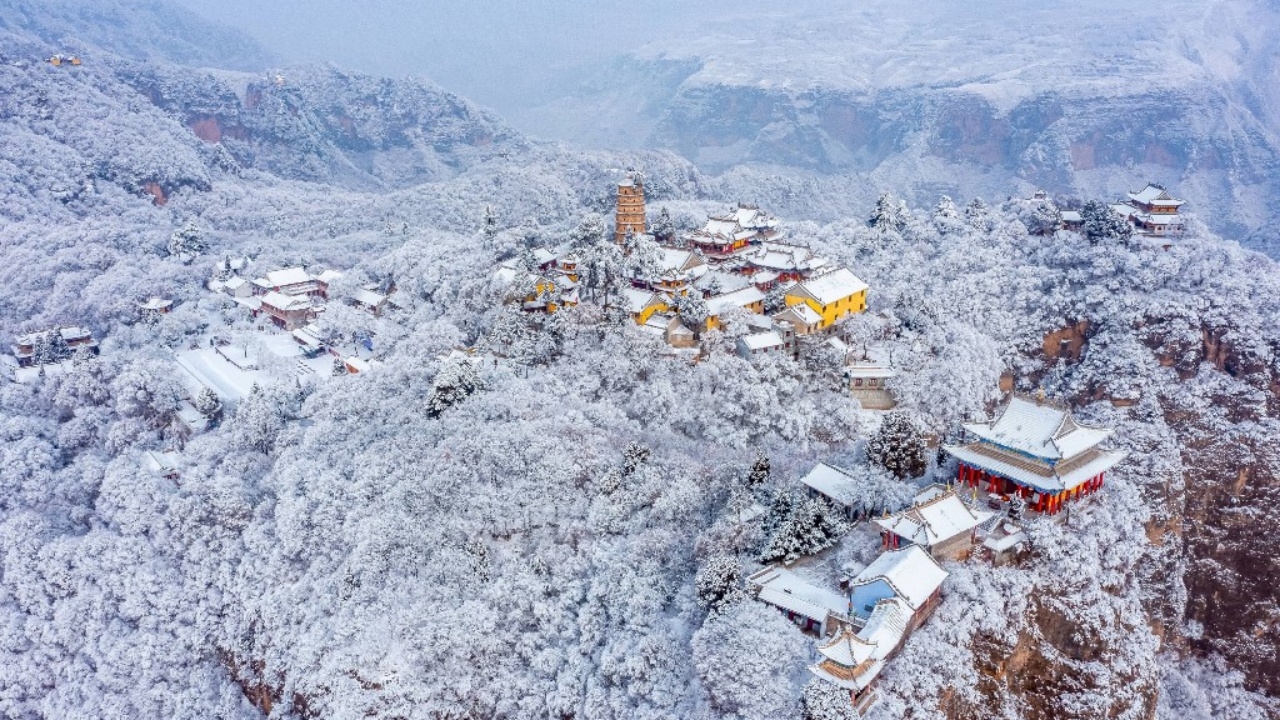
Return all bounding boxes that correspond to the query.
[512,0,1280,251]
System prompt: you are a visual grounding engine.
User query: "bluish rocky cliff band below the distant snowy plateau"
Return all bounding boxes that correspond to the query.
[652,83,1280,250]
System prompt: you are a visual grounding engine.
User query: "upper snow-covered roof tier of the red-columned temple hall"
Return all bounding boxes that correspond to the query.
[964,395,1111,461]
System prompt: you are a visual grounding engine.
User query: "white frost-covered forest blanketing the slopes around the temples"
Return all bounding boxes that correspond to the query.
[0,18,1280,720]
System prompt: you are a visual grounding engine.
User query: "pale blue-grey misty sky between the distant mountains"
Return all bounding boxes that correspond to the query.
[166,0,762,109]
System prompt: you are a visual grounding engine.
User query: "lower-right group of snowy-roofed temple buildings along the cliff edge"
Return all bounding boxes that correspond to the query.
[748,395,1124,712]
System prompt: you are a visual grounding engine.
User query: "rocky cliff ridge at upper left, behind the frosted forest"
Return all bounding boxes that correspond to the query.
[120,64,526,190]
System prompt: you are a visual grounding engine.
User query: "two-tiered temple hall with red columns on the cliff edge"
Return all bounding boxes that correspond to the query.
[946,395,1125,515]
